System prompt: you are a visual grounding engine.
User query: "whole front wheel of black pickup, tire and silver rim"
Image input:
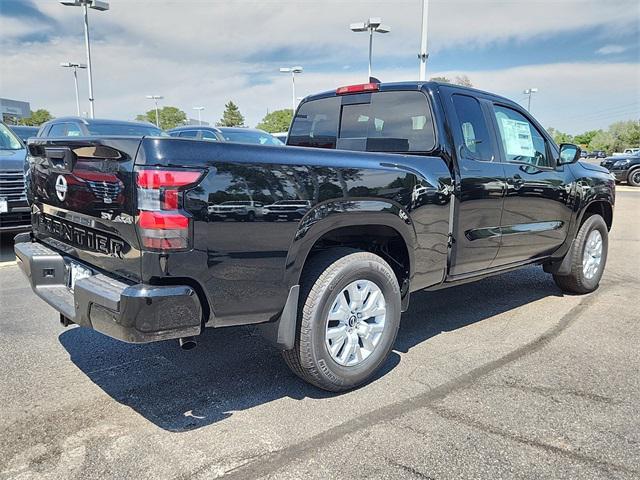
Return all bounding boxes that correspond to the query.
[553,215,609,294]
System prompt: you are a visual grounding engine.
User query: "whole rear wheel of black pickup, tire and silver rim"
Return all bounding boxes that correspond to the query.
[283,248,400,391]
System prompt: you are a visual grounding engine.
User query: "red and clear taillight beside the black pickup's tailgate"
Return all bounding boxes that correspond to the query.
[136,169,203,251]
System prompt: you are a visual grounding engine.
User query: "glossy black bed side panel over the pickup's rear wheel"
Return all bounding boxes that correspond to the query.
[136,139,451,326]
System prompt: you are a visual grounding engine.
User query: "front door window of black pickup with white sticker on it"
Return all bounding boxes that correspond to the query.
[493,105,555,168]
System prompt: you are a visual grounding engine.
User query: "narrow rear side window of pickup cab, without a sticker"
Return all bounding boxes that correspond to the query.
[452,94,493,162]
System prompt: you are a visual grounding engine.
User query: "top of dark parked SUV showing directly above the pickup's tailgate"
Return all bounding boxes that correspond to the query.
[38,117,167,138]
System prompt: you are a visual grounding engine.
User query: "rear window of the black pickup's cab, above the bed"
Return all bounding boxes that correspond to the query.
[287,91,435,153]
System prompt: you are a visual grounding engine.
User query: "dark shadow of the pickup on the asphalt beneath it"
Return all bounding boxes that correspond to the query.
[59,267,561,432]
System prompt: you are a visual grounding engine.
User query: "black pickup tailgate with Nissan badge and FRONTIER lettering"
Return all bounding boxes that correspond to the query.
[27,137,141,281]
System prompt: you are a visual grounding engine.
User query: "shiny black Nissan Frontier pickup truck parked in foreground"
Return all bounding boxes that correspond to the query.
[15,82,615,391]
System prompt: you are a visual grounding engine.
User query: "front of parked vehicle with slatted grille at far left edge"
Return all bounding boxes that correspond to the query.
[0,122,31,233]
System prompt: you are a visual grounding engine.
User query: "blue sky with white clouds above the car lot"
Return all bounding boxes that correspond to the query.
[0,0,640,134]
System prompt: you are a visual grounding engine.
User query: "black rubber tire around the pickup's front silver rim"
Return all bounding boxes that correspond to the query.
[553,215,609,294]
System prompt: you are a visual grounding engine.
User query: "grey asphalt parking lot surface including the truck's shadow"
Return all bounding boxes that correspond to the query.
[0,187,640,479]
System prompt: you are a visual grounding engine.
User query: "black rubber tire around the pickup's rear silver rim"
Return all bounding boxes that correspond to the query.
[283,247,401,392]
